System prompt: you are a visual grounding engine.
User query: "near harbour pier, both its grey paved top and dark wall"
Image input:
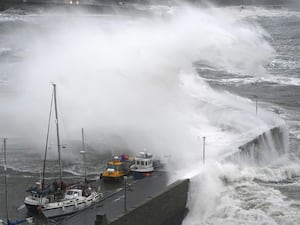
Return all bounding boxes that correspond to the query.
[60,171,189,225]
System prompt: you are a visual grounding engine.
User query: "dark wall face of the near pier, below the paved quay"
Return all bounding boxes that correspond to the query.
[95,179,189,225]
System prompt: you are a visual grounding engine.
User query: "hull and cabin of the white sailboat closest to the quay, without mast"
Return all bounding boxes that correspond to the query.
[41,184,103,218]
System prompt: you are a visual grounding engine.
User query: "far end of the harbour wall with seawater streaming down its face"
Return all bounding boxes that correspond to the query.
[225,126,288,165]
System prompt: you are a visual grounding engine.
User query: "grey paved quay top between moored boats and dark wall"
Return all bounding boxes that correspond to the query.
[52,172,167,225]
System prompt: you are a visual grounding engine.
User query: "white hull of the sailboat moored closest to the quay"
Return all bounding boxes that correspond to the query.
[41,192,102,218]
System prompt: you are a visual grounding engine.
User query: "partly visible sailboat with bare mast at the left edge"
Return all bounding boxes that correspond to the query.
[0,138,32,225]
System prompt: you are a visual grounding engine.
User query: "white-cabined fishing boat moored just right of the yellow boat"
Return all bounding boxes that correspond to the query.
[130,152,154,173]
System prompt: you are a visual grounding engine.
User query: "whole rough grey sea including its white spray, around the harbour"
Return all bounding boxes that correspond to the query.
[0,1,300,225]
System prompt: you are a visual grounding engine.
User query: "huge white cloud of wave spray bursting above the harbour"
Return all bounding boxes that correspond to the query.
[1,7,282,153]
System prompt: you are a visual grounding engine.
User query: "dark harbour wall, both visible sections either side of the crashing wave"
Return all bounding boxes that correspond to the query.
[95,126,288,225]
